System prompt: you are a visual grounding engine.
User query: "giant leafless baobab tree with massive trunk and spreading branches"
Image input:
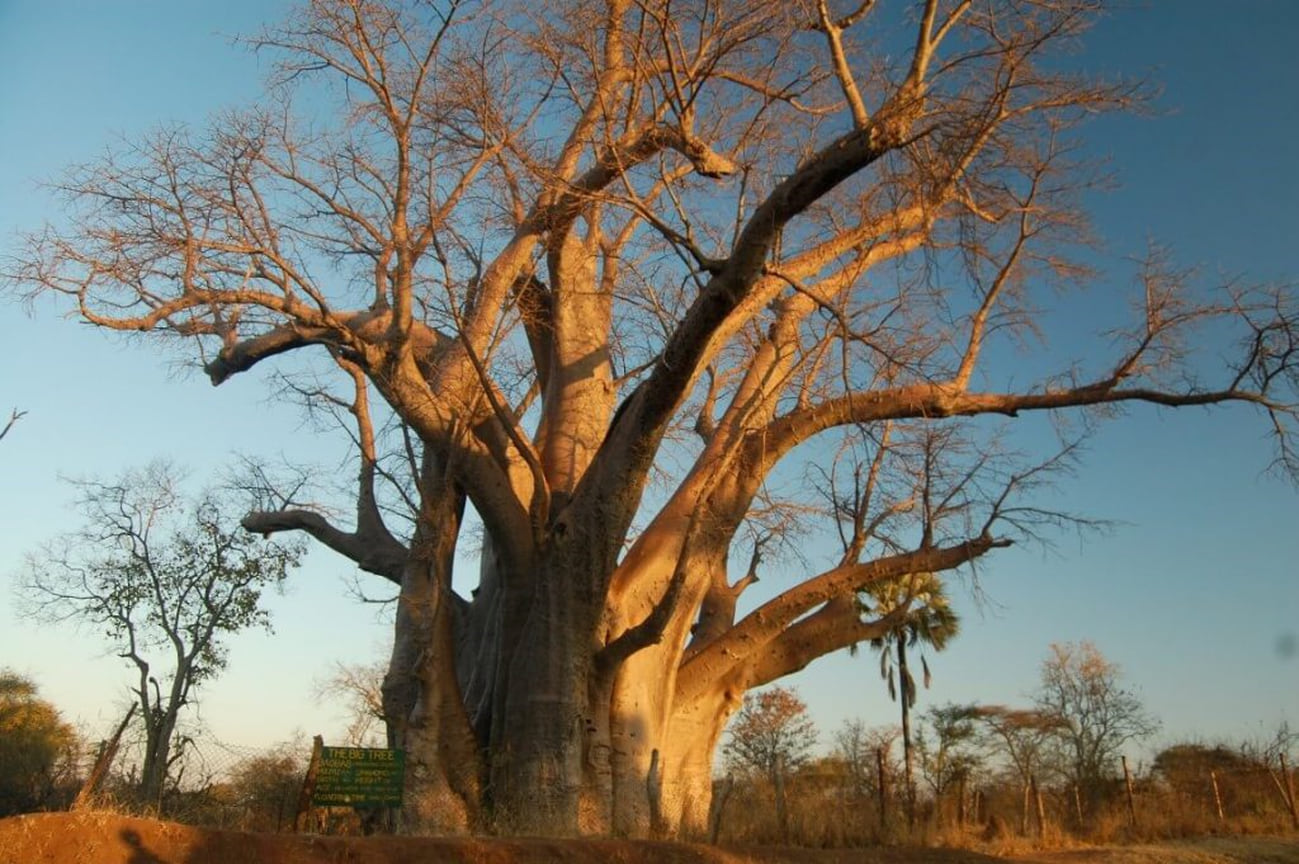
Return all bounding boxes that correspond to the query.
[8,0,1295,834]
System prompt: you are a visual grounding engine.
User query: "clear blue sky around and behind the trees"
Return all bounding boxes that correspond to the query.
[0,0,1299,763]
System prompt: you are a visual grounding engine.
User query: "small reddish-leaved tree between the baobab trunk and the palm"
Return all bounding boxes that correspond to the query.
[726,687,817,780]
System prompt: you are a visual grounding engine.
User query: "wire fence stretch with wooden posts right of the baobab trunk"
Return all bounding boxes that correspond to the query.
[713,759,1299,846]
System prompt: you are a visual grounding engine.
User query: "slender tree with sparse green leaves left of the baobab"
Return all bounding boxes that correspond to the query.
[22,463,301,806]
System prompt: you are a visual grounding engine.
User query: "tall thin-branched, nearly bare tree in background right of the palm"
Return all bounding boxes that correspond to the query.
[1037,641,1159,804]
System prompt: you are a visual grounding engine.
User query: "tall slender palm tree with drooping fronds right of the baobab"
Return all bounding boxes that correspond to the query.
[859,573,960,825]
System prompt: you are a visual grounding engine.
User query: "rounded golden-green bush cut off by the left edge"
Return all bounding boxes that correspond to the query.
[0,669,78,816]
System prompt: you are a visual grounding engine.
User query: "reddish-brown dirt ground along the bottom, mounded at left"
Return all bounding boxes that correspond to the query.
[0,812,1299,864]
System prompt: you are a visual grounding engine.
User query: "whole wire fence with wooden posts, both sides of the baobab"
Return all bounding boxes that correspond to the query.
[61,722,1299,846]
